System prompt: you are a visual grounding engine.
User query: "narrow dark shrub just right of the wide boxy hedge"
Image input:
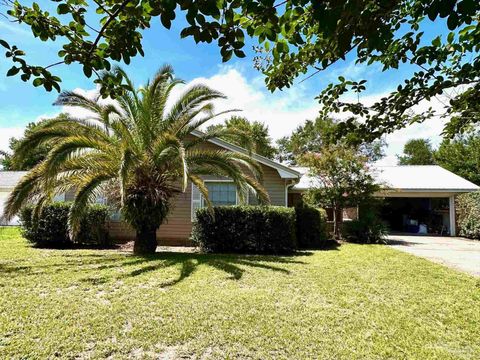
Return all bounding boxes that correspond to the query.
[295,203,328,249]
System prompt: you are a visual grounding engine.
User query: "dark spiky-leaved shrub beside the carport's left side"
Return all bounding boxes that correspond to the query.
[342,200,388,244]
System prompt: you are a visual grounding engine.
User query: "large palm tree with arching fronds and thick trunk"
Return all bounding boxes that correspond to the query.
[5,66,268,254]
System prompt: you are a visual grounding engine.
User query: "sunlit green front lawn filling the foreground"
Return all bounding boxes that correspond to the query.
[0,228,480,359]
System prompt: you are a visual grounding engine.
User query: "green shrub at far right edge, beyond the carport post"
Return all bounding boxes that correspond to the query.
[456,191,480,240]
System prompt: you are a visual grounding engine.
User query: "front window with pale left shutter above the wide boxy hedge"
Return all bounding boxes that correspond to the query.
[191,181,238,220]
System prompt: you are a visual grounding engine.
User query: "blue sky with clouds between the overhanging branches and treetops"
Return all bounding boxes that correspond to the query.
[0,9,450,165]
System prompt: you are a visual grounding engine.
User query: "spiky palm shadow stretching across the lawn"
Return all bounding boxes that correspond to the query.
[0,250,320,287]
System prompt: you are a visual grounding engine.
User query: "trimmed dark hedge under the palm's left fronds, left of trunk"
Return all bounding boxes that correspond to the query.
[20,202,112,249]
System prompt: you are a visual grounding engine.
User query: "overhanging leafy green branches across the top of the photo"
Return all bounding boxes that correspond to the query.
[0,0,480,139]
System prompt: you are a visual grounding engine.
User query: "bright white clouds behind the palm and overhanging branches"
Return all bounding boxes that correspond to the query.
[0,66,456,165]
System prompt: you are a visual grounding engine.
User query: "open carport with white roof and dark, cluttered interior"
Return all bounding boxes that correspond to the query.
[375,165,479,236]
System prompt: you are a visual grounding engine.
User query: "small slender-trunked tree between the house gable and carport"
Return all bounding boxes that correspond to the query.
[300,145,378,238]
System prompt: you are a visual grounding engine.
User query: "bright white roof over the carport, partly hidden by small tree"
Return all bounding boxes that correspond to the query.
[293,165,480,192]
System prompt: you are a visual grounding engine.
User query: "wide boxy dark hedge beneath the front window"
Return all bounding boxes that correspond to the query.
[192,206,296,254]
